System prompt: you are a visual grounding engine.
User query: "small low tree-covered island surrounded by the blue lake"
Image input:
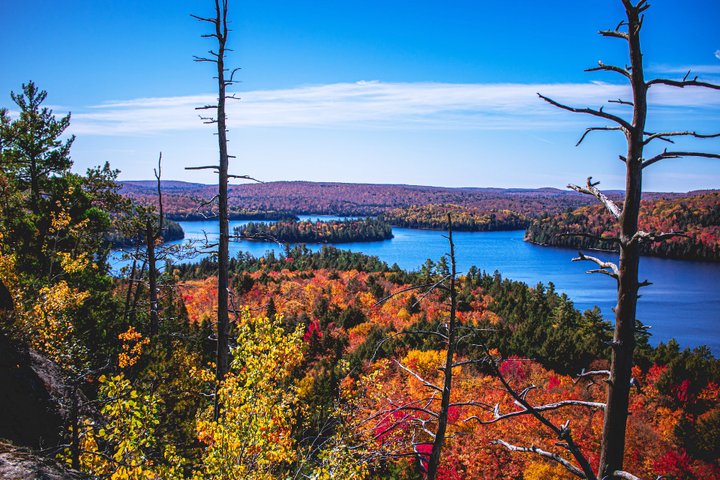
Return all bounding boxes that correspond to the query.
[235,218,393,243]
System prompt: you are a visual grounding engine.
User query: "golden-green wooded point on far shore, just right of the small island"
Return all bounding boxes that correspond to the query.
[380,205,530,232]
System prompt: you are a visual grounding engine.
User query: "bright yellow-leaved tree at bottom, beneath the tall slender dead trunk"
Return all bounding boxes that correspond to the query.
[197,310,303,479]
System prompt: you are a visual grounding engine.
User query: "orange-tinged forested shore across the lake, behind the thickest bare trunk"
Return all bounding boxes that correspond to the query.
[525,192,720,261]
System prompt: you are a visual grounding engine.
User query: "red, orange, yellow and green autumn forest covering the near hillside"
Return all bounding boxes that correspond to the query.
[0,83,720,479]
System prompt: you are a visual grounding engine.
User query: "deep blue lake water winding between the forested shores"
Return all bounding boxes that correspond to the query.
[109,216,720,356]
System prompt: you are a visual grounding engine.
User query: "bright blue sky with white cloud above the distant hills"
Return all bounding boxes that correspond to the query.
[0,0,720,191]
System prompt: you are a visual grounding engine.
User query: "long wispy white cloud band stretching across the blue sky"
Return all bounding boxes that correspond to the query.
[67,81,720,135]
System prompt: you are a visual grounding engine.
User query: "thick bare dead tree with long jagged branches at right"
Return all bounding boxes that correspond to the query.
[538,0,720,478]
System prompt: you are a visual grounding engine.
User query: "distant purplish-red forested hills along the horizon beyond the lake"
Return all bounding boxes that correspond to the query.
[122,181,704,220]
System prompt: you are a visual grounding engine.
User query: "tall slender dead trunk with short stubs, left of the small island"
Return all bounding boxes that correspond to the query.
[187,0,238,419]
